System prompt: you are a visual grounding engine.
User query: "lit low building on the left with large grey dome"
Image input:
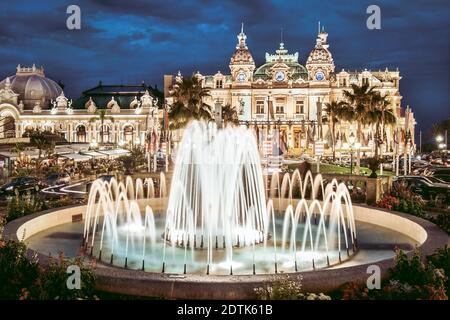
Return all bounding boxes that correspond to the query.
[0,65,163,149]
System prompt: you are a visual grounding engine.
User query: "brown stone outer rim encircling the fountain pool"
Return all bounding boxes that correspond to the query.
[3,204,450,299]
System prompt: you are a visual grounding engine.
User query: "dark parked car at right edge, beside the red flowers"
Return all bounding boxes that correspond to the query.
[395,176,450,204]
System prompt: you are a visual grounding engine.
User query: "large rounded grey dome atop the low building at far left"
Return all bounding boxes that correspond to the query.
[0,64,62,110]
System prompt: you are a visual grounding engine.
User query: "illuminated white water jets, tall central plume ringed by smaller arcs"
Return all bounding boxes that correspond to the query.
[84,122,357,274]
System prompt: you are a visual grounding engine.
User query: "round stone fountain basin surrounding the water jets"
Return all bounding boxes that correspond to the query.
[4,199,450,299]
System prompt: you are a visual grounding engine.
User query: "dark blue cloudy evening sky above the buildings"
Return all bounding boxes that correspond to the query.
[0,0,450,130]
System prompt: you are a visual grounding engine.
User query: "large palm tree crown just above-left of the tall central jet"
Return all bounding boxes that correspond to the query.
[169,76,213,129]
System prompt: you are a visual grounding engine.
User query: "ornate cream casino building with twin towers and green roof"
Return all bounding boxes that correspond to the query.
[164,28,416,155]
